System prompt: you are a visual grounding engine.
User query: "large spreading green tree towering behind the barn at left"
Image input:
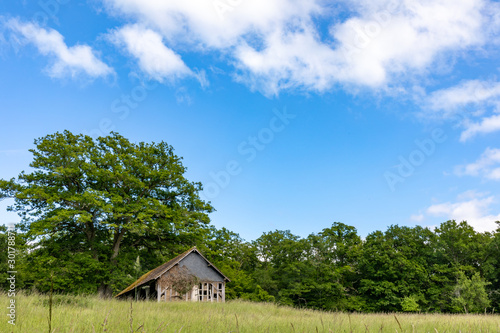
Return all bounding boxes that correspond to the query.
[0,131,213,296]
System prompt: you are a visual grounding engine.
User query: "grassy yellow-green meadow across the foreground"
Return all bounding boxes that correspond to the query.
[0,293,500,333]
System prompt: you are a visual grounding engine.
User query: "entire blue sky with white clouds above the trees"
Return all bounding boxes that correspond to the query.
[0,0,500,240]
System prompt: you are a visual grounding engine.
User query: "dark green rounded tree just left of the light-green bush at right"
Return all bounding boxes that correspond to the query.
[358,226,433,311]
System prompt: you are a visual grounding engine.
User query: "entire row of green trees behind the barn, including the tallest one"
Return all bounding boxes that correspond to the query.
[0,131,500,313]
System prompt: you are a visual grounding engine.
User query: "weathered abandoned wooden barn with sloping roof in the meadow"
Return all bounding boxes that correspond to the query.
[115,246,230,302]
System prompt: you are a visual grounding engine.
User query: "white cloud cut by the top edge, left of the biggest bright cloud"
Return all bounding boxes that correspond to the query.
[103,0,320,49]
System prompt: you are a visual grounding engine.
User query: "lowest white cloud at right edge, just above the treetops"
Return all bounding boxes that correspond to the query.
[426,191,500,232]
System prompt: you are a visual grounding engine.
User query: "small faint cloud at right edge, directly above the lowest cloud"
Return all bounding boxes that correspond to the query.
[455,148,500,180]
